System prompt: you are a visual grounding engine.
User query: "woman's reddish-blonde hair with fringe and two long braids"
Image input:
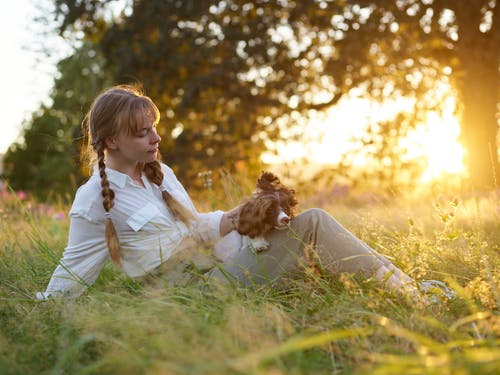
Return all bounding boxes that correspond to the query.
[82,85,193,265]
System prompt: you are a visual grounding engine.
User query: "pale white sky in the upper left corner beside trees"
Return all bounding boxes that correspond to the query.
[0,0,69,154]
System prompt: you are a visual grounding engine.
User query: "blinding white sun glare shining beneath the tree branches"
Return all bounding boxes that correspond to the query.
[262,98,464,182]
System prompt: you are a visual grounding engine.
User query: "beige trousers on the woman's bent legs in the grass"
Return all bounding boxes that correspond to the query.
[207,208,416,293]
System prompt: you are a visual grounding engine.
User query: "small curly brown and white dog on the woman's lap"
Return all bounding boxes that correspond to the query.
[215,172,298,260]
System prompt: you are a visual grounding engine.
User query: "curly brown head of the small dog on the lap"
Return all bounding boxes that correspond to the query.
[237,172,298,237]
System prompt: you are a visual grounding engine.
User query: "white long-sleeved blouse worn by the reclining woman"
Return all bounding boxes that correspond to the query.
[37,164,224,299]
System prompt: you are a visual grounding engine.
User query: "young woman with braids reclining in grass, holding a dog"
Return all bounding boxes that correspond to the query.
[38,86,434,299]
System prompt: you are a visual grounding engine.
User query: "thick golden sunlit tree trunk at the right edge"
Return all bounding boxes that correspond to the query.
[448,1,500,186]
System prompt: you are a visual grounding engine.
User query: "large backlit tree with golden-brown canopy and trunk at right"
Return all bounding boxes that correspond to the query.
[49,0,500,191]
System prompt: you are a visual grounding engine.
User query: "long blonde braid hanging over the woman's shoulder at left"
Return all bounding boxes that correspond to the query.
[95,141,121,266]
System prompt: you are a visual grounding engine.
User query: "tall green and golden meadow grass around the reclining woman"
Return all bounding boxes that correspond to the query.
[0,186,500,375]
